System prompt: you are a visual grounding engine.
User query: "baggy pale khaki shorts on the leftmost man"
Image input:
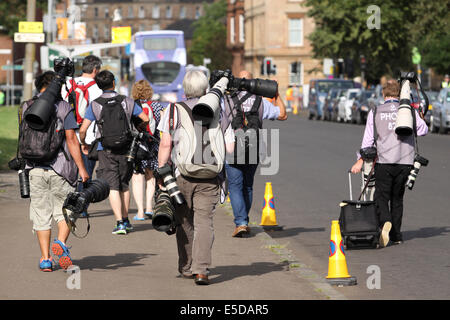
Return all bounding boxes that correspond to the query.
[30,168,75,231]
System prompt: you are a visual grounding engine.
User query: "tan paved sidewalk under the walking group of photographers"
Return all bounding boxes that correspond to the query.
[0,172,343,300]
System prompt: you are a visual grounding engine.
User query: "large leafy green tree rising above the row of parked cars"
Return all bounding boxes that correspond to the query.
[305,0,414,81]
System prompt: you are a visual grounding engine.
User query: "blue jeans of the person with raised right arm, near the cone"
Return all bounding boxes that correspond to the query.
[225,163,258,227]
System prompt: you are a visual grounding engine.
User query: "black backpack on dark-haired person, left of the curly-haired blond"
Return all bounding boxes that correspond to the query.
[95,95,132,153]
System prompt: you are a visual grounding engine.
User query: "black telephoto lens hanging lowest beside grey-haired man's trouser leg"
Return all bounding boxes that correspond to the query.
[152,190,175,232]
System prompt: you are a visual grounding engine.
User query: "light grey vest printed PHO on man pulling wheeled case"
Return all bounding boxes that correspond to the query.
[374,100,416,165]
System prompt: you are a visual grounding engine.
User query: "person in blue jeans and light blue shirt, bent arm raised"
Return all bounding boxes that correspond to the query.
[222,70,287,237]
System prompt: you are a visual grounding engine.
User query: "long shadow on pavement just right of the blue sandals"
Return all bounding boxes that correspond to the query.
[73,253,156,270]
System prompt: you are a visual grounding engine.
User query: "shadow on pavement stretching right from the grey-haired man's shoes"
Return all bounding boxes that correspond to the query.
[211,262,288,283]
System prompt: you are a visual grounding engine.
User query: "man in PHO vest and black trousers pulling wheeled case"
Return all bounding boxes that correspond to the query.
[351,79,428,247]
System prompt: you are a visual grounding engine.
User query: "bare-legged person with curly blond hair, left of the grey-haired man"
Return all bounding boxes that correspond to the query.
[131,80,163,221]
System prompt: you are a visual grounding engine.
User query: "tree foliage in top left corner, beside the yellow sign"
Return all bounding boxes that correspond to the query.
[0,0,47,38]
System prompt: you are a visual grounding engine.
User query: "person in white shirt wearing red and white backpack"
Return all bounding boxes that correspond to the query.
[62,55,103,216]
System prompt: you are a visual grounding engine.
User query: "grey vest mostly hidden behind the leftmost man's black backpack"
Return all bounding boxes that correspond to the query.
[20,100,78,186]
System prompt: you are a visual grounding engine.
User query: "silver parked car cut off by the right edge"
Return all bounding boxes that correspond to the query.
[430,88,450,134]
